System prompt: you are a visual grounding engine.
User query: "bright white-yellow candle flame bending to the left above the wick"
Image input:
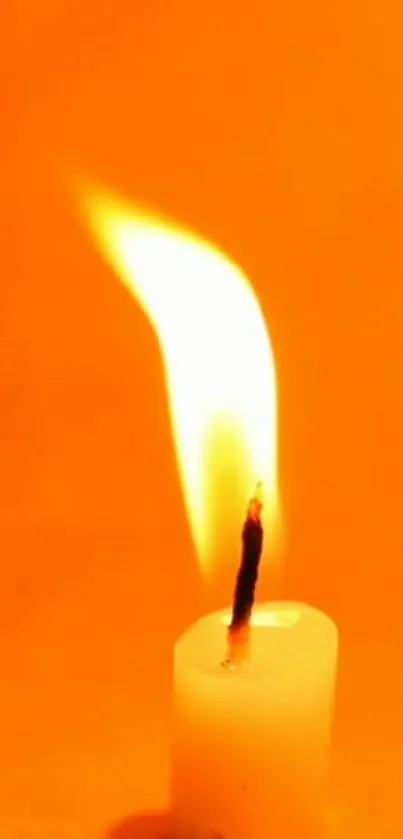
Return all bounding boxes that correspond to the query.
[79,184,279,571]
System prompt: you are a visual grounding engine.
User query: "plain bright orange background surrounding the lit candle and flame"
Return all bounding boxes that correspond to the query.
[4,0,403,839]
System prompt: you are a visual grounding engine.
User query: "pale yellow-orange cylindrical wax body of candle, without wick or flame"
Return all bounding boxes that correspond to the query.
[172,603,338,839]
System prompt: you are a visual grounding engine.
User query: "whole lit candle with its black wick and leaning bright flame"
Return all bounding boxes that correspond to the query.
[81,187,337,839]
